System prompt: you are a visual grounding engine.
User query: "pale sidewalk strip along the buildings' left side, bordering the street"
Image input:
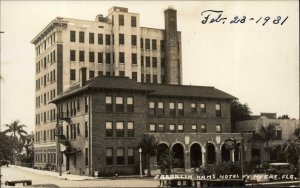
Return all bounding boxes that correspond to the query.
[9,165,98,181]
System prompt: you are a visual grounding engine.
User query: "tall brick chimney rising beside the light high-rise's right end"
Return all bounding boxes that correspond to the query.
[165,8,181,85]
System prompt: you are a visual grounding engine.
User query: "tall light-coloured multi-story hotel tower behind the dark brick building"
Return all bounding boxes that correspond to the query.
[32,7,182,170]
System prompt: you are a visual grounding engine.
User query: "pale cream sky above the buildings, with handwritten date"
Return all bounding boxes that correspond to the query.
[0,0,299,132]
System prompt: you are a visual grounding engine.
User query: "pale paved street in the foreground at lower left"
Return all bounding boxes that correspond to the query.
[1,166,159,187]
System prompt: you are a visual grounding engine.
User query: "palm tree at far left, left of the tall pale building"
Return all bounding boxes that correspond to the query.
[3,120,27,163]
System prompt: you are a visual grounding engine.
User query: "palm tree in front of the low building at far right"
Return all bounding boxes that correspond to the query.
[254,124,276,159]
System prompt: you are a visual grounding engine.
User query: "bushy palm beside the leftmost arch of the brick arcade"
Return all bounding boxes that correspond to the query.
[139,135,158,176]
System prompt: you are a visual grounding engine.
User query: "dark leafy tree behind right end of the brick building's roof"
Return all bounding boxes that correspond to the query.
[230,99,252,129]
